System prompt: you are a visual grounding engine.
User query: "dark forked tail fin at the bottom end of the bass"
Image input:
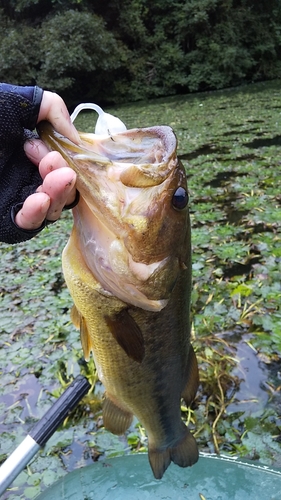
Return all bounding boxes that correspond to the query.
[148,424,199,479]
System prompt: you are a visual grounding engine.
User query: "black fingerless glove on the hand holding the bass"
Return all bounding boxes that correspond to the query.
[0,83,43,243]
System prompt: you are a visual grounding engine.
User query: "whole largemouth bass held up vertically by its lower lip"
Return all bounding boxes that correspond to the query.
[38,111,198,479]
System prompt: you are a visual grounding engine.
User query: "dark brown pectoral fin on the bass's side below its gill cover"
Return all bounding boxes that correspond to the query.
[105,309,145,363]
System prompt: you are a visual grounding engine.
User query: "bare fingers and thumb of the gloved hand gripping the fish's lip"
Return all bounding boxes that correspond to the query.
[15,91,79,230]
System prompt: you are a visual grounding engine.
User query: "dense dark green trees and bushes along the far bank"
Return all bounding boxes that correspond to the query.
[0,0,281,103]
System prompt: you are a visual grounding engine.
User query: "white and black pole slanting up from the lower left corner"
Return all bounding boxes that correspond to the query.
[0,375,91,496]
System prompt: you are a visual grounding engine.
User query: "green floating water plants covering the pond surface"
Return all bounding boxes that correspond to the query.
[0,82,281,500]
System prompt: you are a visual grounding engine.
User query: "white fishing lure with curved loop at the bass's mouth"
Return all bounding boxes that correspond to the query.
[70,102,127,136]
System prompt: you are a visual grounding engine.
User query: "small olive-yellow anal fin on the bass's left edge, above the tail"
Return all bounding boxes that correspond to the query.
[102,394,133,435]
